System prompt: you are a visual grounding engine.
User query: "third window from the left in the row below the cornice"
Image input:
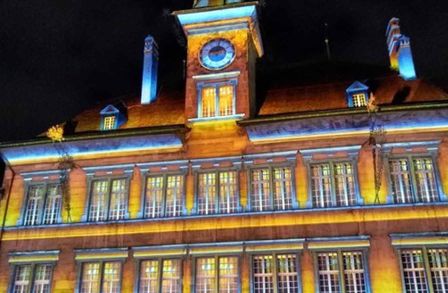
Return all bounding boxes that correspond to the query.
[144,175,184,218]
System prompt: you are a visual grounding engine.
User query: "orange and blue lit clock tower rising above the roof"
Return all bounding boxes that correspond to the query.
[174,0,263,122]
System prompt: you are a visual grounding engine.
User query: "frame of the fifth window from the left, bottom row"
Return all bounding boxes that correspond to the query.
[248,250,303,293]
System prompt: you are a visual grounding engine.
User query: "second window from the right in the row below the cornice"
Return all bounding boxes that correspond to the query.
[310,162,356,208]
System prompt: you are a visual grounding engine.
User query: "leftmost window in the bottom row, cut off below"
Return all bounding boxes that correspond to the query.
[11,264,53,293]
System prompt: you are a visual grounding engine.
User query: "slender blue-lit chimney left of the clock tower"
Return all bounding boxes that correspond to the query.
[141,35,159,104]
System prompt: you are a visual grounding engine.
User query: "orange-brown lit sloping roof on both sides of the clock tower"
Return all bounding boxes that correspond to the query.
[70,63,448,133]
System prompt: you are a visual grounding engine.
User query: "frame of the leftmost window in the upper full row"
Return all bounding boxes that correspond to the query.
[18,180,64,227]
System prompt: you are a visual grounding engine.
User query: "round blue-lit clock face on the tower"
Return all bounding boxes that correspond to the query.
[199,39,235,70]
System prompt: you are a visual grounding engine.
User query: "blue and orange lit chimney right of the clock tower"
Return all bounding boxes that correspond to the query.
[386,17,417,80]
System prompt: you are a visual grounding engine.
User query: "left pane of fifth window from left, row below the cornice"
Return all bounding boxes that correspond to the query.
[251,169,272,211]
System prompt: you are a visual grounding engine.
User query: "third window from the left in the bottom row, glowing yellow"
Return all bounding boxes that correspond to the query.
[138,259,182,293]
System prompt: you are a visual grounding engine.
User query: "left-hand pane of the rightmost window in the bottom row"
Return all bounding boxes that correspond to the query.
[401,250,428,293]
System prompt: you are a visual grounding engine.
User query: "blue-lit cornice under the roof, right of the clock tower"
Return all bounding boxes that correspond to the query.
[239,103,448,144]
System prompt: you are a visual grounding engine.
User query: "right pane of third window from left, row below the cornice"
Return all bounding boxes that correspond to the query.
[165,175,184,217]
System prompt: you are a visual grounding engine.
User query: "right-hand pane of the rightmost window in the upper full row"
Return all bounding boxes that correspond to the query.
[414,158,439,202]
